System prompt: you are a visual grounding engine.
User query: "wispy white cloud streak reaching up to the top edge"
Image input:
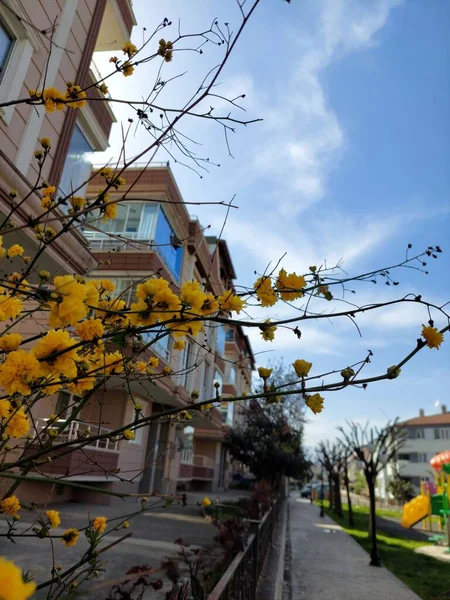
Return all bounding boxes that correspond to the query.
[254,0,403,215]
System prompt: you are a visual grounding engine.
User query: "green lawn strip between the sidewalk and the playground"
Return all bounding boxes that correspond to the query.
[316,502,450,600]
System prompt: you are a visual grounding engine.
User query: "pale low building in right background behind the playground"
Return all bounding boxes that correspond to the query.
[395,404,450,491]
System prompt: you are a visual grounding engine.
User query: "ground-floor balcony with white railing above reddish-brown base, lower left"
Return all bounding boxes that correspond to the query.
[30,419,119,480]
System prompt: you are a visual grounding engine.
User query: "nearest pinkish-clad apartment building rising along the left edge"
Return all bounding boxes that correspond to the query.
[0,0,136,502]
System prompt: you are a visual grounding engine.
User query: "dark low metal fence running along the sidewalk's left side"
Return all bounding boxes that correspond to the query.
[208,496,283,600]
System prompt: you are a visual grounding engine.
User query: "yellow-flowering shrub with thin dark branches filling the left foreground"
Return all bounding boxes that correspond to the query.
[0,2,449,600]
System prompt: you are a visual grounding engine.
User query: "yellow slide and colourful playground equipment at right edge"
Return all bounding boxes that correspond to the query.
[402,450,450,547]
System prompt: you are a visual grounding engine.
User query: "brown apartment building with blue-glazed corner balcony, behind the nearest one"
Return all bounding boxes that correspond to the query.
[77,163,254,494]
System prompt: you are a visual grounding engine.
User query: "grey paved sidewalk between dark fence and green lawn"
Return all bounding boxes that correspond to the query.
[289,495,419,600]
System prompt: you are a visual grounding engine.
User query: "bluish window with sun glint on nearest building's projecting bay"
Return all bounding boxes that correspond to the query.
[58,125,94,199]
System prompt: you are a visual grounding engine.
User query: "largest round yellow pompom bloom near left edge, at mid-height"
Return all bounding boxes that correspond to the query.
[0,350,41,395]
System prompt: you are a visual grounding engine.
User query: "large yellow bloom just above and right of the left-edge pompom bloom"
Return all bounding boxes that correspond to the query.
[33,329,78,377]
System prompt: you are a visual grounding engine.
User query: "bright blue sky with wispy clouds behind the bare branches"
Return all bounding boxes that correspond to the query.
[96,0,450,444]
